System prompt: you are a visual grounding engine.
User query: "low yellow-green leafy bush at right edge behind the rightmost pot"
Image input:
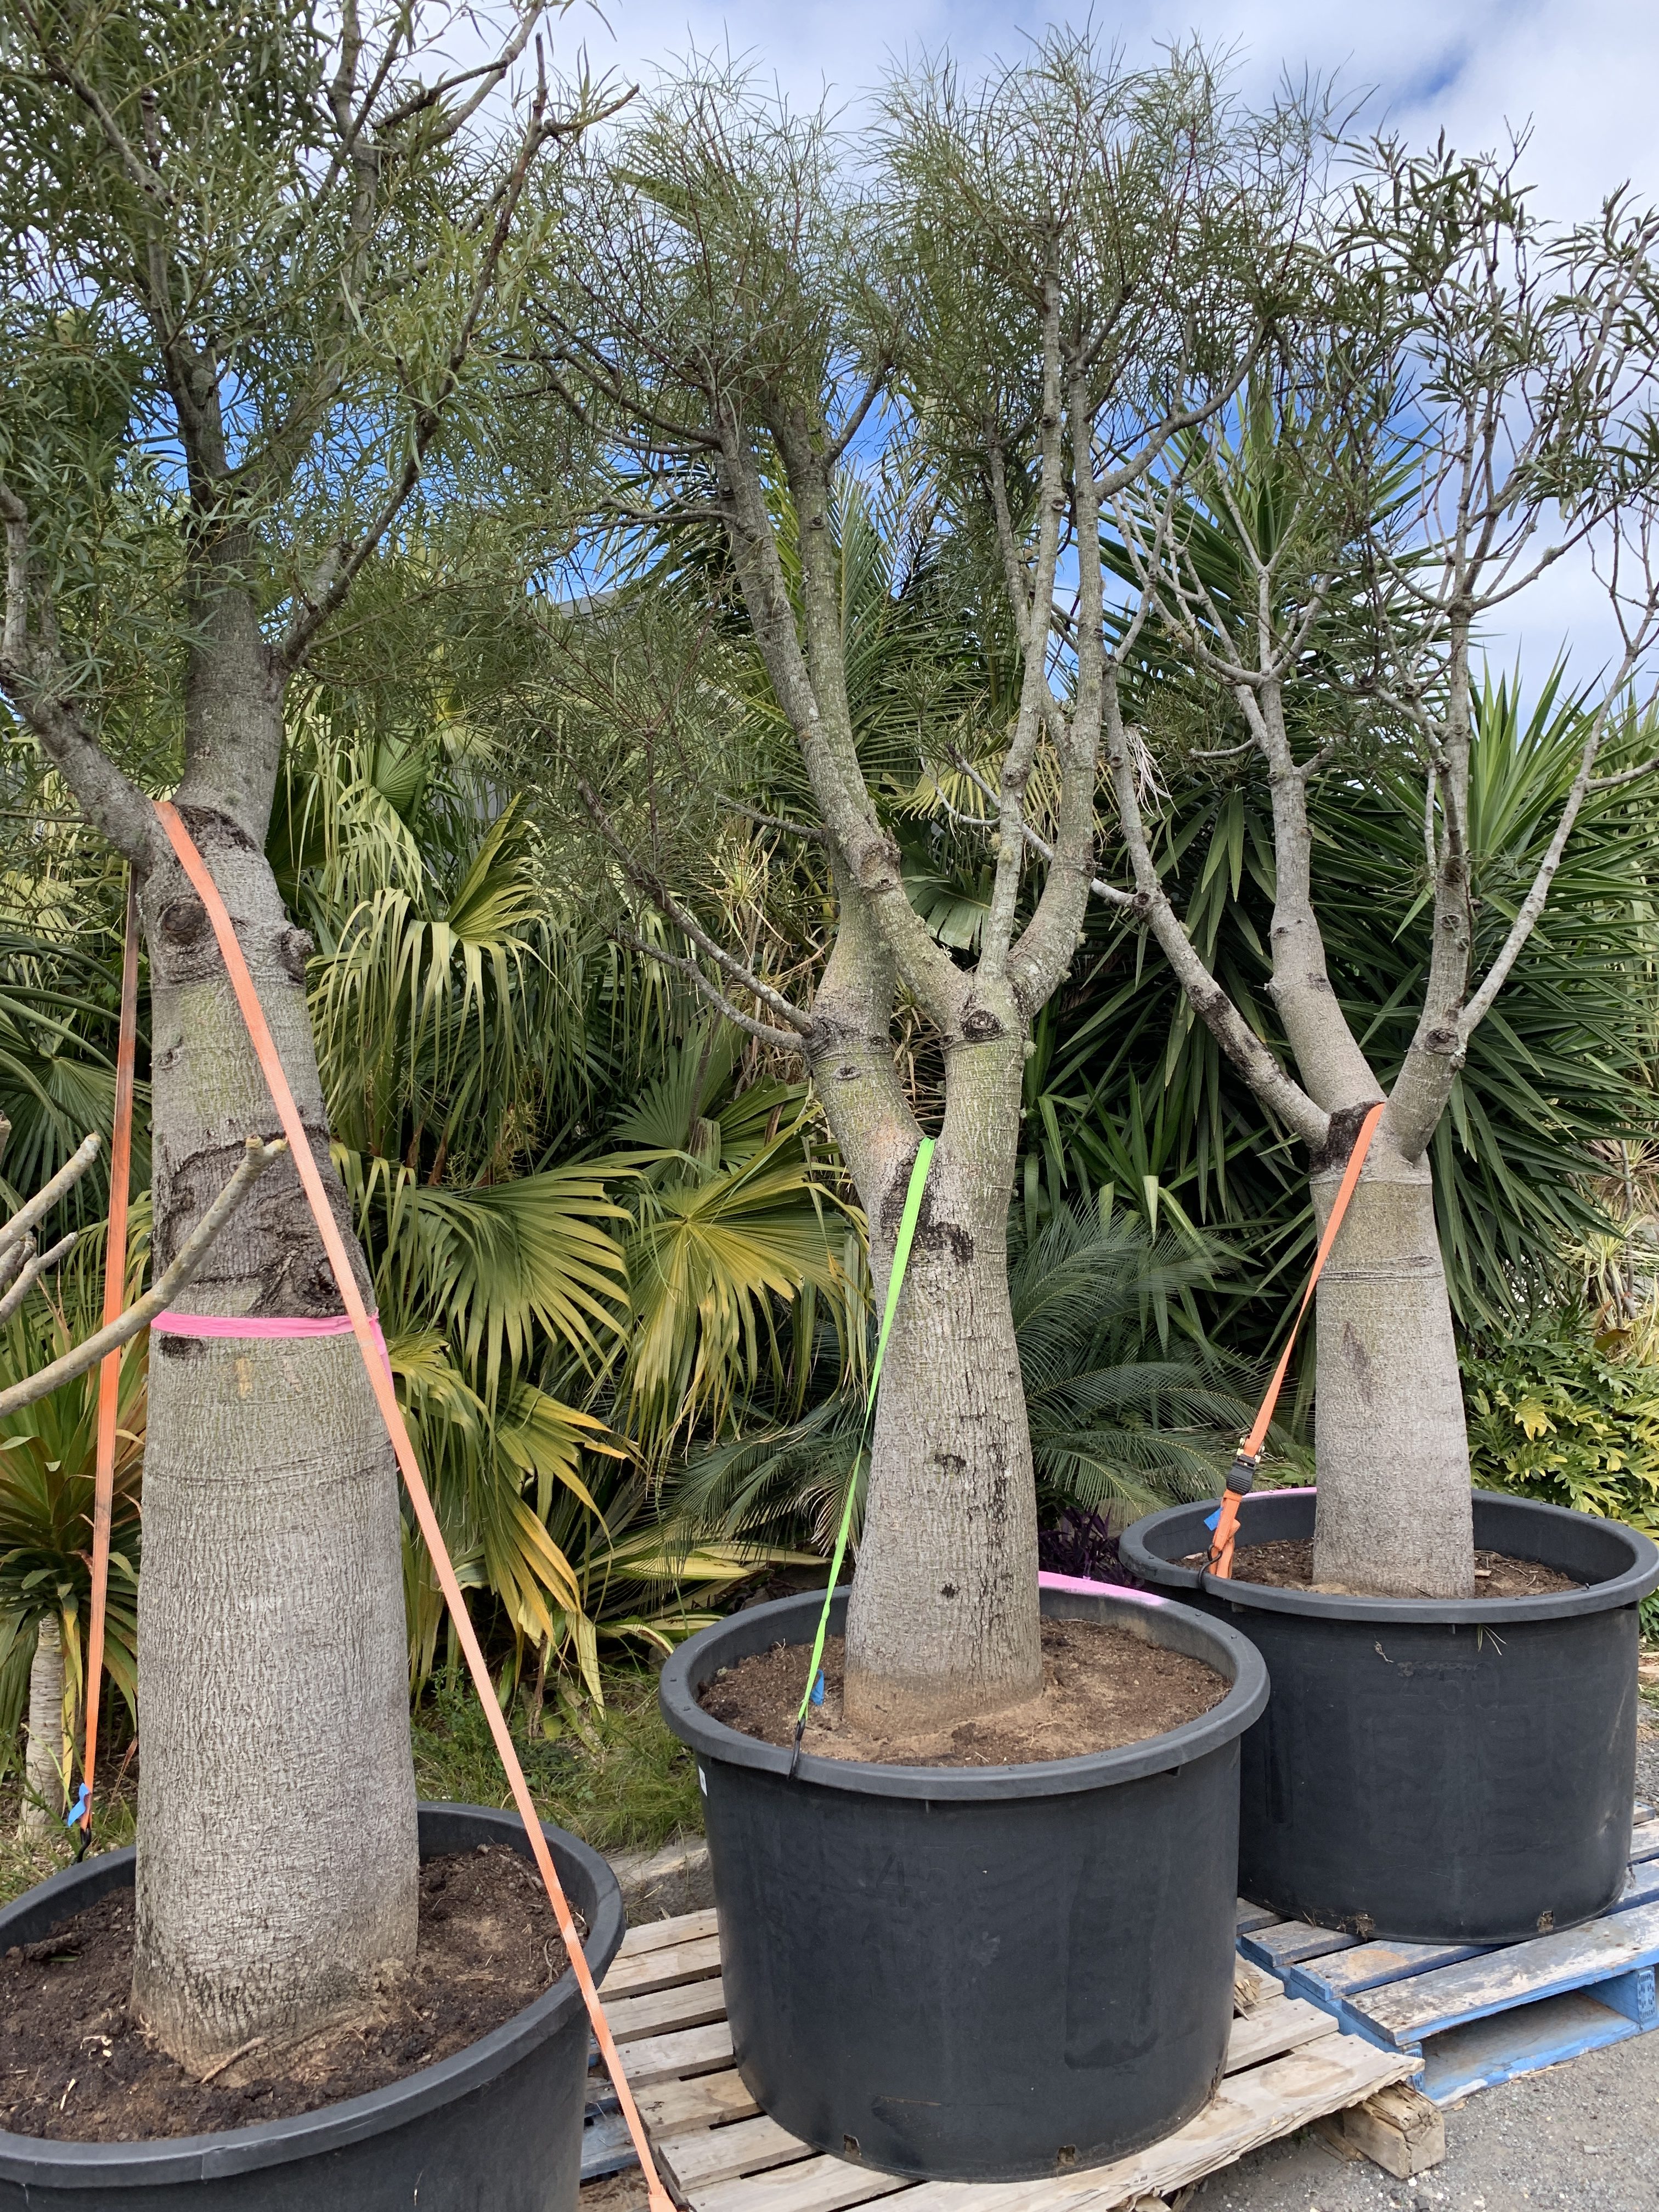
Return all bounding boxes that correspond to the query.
[1462,1331,1659,1635]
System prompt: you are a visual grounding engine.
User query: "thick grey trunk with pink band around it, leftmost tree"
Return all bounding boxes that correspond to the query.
[133,792,418,2066]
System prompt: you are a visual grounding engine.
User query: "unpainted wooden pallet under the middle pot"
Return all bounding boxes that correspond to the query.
[584,1911,1418,2212]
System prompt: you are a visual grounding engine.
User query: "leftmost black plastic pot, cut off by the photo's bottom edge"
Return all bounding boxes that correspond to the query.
[0,1805,626,2212]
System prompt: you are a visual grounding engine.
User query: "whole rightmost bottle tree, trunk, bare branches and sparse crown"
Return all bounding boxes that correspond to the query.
[1104,144,1659,1597]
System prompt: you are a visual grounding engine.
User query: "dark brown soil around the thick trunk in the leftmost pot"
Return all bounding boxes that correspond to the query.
[0,1845,566,2143]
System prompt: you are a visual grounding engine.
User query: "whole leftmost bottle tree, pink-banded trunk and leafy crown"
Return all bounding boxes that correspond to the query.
[0,0,610,2064]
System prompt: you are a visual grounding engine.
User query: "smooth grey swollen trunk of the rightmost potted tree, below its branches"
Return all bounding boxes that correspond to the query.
[1312,1121,1475,1597]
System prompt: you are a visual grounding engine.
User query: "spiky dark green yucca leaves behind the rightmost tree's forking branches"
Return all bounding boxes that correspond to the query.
[1024,681,1659,1342]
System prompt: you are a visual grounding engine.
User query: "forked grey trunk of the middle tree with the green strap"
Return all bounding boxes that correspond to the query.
[814,978,1042,1728]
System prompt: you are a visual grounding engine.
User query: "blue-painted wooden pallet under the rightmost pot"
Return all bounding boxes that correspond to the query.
[1239,1805,1659,2103]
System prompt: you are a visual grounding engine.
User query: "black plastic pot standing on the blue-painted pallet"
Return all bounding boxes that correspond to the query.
[1121,1491,1659,1944]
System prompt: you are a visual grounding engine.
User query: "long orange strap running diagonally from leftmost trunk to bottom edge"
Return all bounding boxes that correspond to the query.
[155,801,675,2212]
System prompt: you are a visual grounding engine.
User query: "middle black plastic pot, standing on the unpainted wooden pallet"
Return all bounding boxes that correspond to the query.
[662,1590,1267,2181]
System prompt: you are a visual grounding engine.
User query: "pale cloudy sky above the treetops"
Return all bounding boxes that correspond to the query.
[557,0,1659,679]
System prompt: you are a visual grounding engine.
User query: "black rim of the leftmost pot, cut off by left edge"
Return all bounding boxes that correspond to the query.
[0,1798,626,2188]
